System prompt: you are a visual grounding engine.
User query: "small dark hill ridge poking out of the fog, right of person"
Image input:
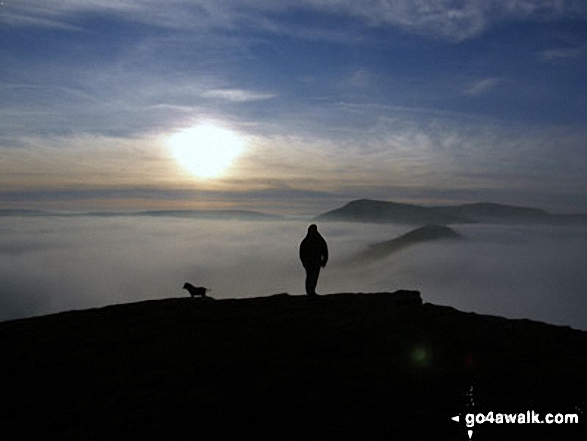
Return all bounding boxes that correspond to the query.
[356,225,462,261]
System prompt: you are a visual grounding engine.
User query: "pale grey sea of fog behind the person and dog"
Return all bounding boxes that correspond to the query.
[0,216,587,330]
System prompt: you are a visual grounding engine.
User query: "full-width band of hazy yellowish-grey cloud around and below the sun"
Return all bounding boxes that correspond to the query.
[0,117,587,213]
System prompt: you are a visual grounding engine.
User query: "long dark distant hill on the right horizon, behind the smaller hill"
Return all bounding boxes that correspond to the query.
[316,199,587,225]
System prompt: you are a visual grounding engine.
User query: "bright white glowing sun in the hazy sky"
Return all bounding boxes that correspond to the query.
[167,124,244,179]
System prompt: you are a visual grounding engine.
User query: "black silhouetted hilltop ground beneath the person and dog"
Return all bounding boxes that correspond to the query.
[0,292,587,441]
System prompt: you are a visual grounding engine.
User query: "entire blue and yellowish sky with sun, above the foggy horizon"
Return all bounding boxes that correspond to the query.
[0,0,587,214]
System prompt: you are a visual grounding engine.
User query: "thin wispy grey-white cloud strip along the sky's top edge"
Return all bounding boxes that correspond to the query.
[4,0,587,41]
